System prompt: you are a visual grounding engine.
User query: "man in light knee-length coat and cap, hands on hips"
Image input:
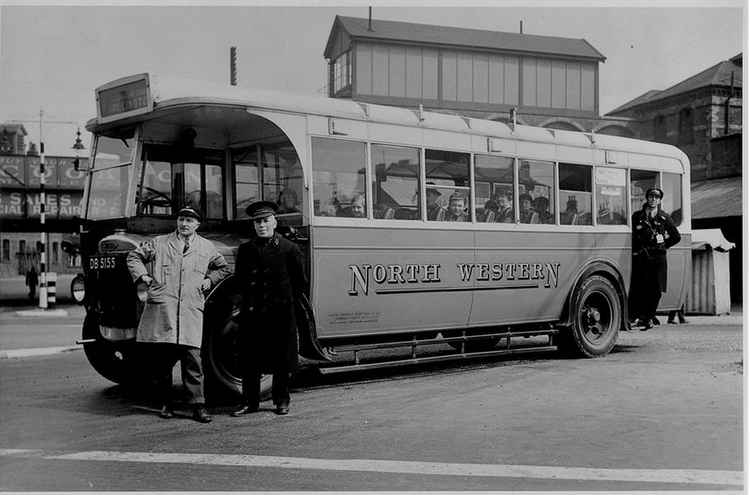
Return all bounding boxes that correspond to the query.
[127,207,231,423]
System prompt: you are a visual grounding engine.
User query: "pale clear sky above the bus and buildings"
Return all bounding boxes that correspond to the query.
[0,0,746,156]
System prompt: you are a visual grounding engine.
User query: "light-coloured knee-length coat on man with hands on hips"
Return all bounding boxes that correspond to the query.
[127,231,231,348]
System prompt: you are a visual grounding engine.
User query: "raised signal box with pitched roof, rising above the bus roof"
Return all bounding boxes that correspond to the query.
[324,16,632,136]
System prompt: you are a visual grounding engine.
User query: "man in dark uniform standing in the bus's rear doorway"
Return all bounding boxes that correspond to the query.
[630,187,680,330]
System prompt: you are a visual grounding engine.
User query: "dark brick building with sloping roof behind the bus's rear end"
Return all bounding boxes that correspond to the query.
[607,53,742,302]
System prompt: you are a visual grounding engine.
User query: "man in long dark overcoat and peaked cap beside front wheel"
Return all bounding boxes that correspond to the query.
[232,201,307,416]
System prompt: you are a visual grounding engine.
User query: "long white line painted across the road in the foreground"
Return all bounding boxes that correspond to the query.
[0,449,744,486]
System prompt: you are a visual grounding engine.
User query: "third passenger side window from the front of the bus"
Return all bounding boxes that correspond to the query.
[425,150,471,222]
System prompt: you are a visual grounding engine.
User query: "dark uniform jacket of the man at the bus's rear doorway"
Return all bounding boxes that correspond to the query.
[631,207,680,292]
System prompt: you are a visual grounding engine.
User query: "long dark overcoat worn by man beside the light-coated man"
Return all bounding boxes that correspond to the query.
[234,233,307,371]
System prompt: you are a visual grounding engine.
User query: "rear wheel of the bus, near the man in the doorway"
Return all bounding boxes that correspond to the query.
[561,275,622,357]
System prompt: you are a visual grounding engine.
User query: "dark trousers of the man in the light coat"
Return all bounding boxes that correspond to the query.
[150,344,206,404]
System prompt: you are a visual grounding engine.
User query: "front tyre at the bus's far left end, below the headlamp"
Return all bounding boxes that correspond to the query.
[82,313,138,385]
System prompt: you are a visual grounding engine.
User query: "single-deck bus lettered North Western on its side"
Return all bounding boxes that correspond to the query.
[82,74,690,400]
